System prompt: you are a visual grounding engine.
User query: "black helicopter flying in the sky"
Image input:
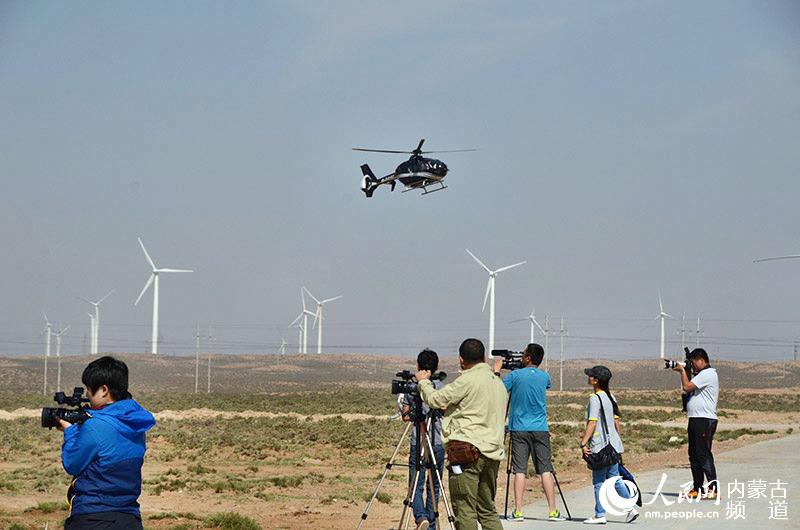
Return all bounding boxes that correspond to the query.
[353,138,475,197]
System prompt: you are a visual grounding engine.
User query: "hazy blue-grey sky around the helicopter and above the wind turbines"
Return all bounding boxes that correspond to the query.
[0,0,800,359]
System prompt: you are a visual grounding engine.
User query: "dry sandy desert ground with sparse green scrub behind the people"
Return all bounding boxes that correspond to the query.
[0,354,800,529]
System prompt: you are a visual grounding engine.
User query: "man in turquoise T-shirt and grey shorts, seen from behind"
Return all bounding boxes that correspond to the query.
[494,343,564,521]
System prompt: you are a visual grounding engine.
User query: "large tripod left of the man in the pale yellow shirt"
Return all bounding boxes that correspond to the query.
[356,392,456,530]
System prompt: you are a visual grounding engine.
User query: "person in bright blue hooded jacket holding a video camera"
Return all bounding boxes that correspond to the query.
[59,357,156,530]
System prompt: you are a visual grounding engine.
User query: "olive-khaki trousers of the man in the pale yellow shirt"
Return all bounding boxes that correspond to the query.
[449,455,503,530]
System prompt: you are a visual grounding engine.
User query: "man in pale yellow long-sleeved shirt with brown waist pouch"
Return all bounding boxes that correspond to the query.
[416,339,506,530]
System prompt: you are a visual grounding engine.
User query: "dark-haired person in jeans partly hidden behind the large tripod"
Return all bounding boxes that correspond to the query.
[401,349,444,530]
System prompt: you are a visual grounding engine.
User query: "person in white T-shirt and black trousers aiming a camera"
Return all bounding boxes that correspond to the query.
[673,348,719,500]
